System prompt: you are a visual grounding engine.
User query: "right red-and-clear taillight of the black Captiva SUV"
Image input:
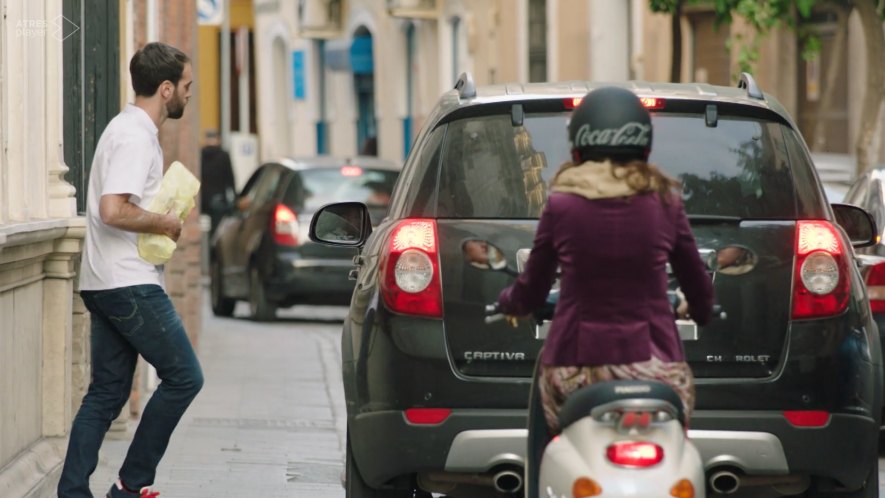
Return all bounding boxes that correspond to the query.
[793,220,849,319]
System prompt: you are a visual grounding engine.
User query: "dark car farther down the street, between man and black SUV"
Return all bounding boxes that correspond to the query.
[210,157,399,320]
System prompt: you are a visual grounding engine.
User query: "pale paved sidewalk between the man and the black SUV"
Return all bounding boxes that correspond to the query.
[91,299,346,498]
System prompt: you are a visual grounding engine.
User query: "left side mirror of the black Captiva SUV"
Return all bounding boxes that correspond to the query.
[309,202,372,247]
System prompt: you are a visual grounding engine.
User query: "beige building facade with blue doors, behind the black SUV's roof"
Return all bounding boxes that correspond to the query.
[253,0,885,169]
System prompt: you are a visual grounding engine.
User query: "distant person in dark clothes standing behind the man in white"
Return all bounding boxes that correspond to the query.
[200,130,236,237]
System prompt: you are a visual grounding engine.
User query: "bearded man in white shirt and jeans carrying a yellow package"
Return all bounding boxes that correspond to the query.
[58,43,203,498]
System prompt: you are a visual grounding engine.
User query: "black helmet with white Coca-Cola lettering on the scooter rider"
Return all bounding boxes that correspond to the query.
[568,86,652,164]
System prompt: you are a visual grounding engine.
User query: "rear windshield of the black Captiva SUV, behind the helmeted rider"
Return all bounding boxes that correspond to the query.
[437,113,796,219]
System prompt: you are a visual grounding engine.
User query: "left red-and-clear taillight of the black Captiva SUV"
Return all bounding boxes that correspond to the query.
[381,219,442,318]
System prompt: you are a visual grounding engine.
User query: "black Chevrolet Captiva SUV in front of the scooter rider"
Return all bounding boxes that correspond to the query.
[311,74,883,497]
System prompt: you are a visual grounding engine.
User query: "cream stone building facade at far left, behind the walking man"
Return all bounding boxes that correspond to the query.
[0,0,87,497]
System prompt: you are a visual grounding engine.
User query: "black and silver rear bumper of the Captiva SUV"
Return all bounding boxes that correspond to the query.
[350,410,878,489]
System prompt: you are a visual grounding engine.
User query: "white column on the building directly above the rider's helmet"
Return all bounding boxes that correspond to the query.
[590,0,630,81]
